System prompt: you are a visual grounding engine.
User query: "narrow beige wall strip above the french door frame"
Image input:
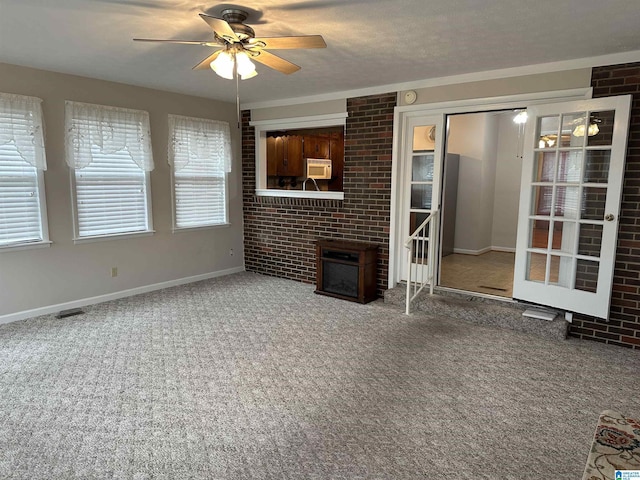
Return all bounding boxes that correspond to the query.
[399,68,591,105]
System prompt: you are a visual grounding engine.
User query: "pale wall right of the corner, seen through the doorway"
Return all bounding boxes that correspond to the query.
[491,112,523,251]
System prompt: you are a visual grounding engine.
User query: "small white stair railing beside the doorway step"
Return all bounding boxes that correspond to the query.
[404,210,440,315]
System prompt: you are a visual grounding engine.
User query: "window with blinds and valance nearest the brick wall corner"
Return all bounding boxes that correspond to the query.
[169,115,231,229]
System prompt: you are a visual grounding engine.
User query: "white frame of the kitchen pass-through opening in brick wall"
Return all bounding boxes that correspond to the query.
[249,112,348,200]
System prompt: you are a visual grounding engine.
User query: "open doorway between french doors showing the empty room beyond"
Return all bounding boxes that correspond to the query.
[439,109,524,298]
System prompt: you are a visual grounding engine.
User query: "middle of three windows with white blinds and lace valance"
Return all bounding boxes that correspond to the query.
[65,102,153,240]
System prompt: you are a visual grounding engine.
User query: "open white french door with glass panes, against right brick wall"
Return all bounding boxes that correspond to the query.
[513,95,631,319]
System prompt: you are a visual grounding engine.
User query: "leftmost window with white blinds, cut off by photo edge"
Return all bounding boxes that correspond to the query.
[0,93,49,248]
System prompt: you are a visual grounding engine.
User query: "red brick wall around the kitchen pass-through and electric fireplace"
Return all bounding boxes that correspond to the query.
[242,93,396,295]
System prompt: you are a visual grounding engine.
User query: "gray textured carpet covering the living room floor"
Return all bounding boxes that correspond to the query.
[0,273,640,480]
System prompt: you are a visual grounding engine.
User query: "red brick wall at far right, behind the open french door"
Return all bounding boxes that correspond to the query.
[569,63,640,349]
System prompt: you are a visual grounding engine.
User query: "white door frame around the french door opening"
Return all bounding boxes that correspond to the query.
[387,87,593,288]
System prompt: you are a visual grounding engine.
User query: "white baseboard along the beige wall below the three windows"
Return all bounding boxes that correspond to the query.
[0,265,245,325]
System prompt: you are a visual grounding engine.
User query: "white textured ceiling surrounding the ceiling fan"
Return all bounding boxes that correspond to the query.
[0,0,640,103]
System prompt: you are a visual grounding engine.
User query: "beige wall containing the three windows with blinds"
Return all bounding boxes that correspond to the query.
[0,64,243,321]
